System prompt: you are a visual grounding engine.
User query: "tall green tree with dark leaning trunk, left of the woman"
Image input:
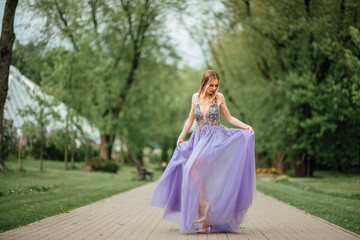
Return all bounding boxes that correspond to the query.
[23,0,188,159]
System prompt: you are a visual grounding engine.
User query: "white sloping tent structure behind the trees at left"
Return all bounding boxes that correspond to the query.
[4,66,100,142]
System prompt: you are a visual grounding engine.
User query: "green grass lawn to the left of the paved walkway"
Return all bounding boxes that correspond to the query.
[0,160,162,232]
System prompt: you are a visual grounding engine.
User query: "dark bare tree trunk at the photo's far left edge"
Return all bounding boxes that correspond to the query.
[0,0,18,170]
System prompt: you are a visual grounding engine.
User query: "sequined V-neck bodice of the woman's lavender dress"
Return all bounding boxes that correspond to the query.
[194,94,220,126]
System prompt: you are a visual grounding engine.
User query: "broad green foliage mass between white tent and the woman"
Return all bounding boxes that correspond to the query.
[14,0,200,161]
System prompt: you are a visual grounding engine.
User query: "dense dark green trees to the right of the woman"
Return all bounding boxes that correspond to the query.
[202,0,360,175]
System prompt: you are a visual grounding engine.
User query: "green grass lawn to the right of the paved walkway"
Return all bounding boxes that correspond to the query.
[256,171,360,234]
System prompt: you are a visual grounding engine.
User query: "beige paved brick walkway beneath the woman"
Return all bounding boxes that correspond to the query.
[0,182,360,240]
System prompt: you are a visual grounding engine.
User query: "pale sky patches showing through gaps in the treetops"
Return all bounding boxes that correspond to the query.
[0,0,205,69]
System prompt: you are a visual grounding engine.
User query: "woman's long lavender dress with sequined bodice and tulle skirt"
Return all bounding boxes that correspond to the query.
[151,94,257,232]
